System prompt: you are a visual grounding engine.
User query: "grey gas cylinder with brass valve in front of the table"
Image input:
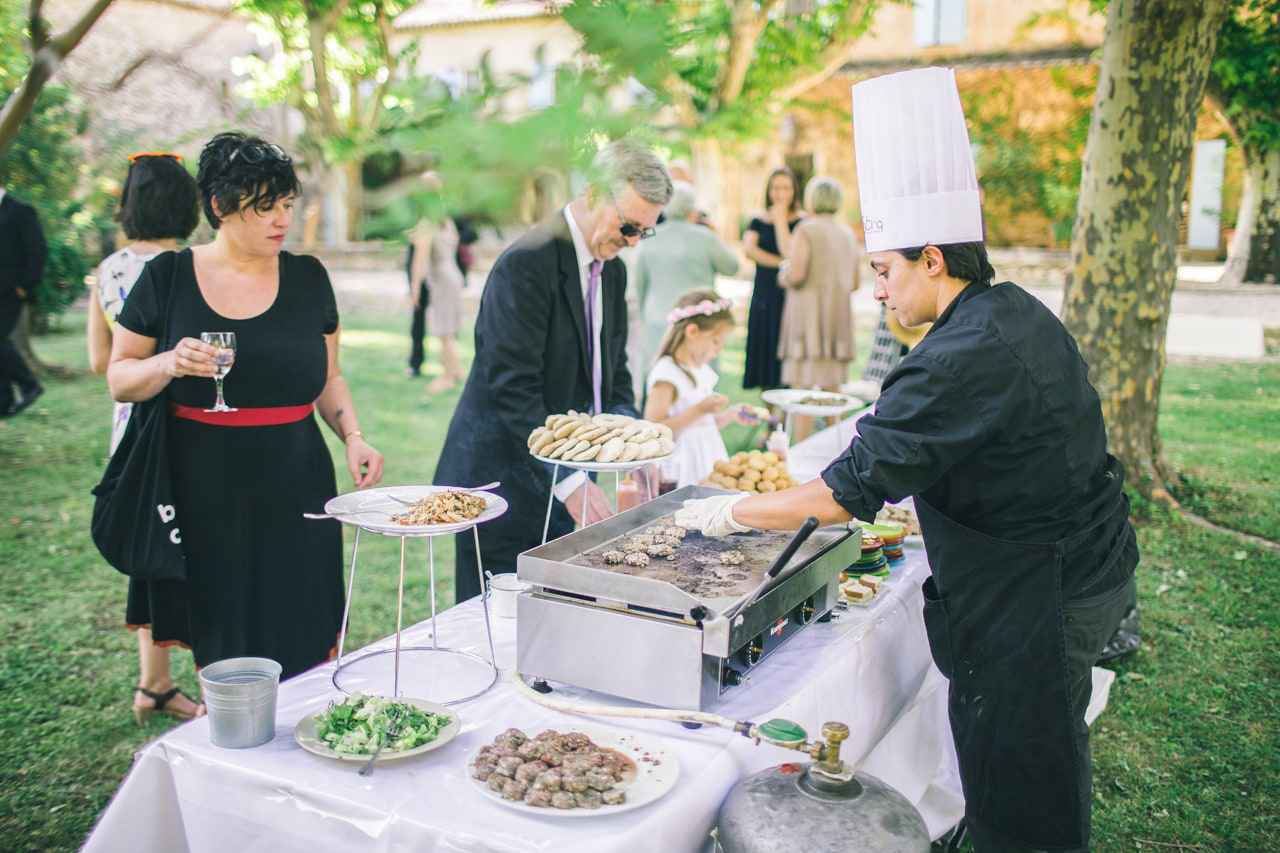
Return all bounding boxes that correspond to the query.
[716,721,929,853]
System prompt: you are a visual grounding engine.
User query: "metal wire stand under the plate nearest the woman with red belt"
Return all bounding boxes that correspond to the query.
[333,524,498,704]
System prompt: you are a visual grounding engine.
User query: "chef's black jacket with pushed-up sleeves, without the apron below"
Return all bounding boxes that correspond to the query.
[822,282,1132,598]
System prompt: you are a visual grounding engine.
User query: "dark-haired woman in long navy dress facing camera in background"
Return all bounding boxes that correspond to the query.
[742,167,801,389]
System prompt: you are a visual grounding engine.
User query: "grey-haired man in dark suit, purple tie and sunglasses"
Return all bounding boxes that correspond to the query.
[435,140,671,601]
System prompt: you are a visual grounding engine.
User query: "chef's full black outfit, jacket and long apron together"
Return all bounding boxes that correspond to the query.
[823,283,1138,850]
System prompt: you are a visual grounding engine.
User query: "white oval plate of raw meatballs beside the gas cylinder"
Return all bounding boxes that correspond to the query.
[467,726,680,817]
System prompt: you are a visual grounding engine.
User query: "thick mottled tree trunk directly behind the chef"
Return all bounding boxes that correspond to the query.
[1062,0,1229,502]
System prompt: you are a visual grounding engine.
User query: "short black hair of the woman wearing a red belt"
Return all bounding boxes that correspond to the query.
[196,131,300,229]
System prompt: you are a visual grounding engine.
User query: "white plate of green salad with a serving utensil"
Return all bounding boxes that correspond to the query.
[293,693,462,761]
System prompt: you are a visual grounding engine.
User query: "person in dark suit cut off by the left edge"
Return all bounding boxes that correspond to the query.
[0,187,47,418]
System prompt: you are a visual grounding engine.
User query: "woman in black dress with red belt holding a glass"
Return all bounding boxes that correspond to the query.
[108,133,383,678]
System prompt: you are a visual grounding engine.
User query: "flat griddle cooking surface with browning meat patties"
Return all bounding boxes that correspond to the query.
[567,515,822,603]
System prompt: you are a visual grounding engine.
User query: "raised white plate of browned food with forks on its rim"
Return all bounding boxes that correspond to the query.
[324,485,507,537]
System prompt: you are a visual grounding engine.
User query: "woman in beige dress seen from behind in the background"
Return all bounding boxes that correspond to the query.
[778,178,860,441]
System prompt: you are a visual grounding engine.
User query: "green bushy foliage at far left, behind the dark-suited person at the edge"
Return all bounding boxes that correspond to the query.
[0,4,106,332]
